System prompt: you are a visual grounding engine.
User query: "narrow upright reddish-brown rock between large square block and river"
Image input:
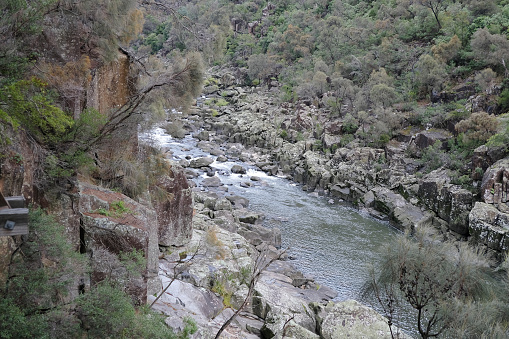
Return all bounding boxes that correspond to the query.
[154,165,193,246]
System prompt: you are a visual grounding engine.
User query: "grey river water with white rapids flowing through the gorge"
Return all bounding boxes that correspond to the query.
[141,128,412,338]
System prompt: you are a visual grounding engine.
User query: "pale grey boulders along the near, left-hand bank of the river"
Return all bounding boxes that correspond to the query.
[143,129,408,338]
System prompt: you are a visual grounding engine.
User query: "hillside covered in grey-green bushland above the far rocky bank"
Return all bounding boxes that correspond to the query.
[136,0,509,184]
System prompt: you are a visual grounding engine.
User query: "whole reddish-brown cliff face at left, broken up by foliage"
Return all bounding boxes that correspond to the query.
[0,42,193,304]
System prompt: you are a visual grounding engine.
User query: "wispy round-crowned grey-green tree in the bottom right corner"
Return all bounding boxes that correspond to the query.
[366,229,509,339]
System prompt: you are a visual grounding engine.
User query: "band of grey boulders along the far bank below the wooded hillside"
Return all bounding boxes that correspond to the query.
[172,67,509,258]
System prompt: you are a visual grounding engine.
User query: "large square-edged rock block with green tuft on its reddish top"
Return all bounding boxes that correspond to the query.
[78,182,160,304]
